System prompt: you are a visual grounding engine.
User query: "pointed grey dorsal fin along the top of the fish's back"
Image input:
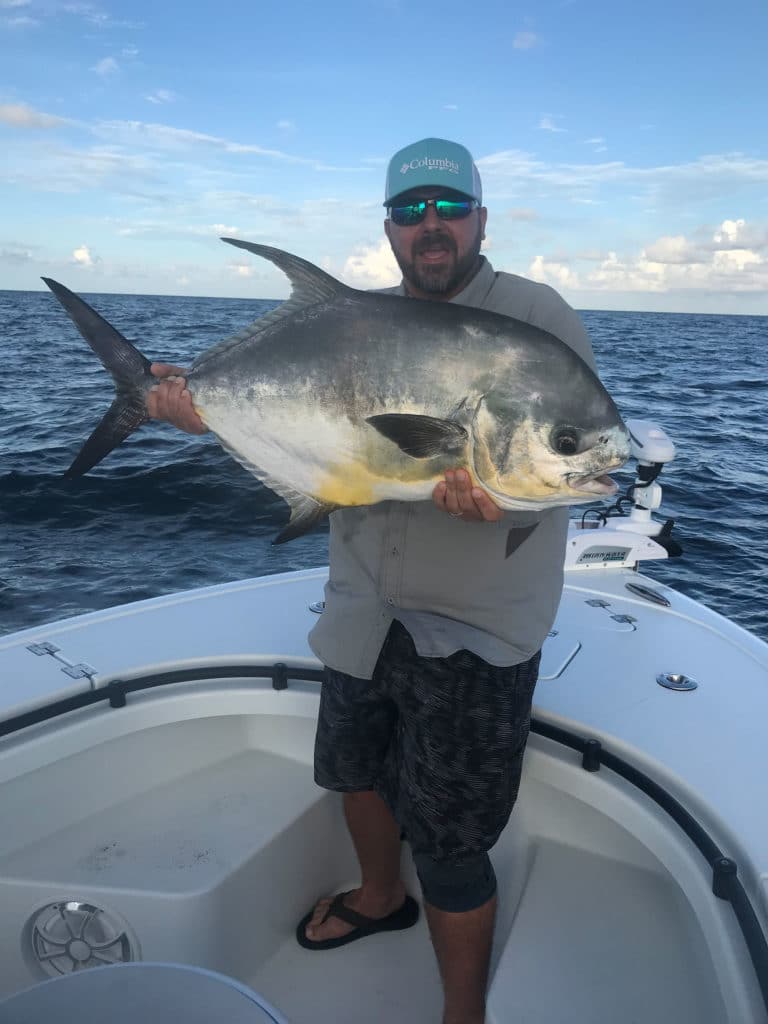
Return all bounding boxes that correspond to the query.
[193,239,354,370]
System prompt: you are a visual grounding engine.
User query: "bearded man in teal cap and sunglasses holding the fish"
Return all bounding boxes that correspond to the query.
[147,138,595,1024]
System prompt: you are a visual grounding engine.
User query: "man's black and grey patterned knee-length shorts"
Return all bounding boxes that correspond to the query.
[314,621,541,862]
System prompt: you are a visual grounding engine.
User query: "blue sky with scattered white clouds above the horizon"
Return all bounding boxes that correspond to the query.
[0,0,768,314]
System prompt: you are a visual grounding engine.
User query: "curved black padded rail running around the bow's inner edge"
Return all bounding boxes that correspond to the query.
[0,662,768,1011]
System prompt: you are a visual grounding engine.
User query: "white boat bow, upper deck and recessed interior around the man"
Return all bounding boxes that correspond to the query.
[0,569,768,1024]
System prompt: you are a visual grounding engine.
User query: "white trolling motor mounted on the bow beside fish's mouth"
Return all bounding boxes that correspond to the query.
[565,420,682,569]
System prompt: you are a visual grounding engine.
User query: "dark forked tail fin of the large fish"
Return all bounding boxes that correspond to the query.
[43,278,155,478]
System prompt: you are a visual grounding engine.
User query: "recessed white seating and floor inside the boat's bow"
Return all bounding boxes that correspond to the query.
[0,716,729,1024]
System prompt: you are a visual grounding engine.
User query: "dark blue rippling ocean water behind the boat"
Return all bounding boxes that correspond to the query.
[0,291,768,639]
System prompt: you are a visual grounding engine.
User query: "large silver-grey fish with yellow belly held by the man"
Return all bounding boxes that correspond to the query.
[43,239,629,543]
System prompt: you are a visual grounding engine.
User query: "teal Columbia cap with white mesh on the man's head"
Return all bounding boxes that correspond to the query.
[384,138,482,206]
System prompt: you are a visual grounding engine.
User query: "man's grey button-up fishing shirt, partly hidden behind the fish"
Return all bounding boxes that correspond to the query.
[309,258,595,679]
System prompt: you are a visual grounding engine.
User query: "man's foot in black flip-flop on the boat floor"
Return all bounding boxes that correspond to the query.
[297,883,419,949]
